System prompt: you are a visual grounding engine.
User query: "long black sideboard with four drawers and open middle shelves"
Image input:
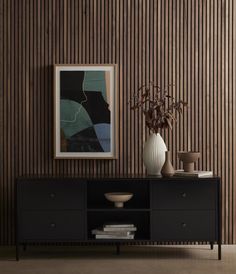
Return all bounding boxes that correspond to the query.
[16,175,221,260]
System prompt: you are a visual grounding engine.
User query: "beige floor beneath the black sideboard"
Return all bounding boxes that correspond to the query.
[0,245,236,274]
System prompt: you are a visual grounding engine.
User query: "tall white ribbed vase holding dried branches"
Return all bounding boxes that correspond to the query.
[143,133,167,175]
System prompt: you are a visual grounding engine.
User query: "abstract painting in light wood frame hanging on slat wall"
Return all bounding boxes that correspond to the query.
[54,64,117,159]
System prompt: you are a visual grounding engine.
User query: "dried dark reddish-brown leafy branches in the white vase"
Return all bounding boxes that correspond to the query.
[129,82,188,133]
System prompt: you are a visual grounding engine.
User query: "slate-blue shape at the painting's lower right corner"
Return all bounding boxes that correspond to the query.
[94,123,111,152]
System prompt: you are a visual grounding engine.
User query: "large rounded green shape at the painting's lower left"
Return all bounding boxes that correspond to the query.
[60,100,93,138]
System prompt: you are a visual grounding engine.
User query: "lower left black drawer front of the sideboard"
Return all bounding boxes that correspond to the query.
[18,210,85,241]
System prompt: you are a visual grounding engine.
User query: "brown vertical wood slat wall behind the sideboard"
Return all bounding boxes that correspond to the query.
[0,0,236,244]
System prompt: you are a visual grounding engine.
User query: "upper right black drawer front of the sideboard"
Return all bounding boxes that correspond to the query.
[151,181,217,210]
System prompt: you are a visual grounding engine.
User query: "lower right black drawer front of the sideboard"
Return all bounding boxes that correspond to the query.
[151,210,217,241]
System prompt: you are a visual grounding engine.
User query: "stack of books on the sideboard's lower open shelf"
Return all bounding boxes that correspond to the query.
[92,223,137,239]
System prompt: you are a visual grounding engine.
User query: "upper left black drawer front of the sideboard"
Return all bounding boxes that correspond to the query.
[17,180,86,210]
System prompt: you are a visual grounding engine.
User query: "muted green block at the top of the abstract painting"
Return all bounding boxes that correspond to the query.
[83,71,107,101]
